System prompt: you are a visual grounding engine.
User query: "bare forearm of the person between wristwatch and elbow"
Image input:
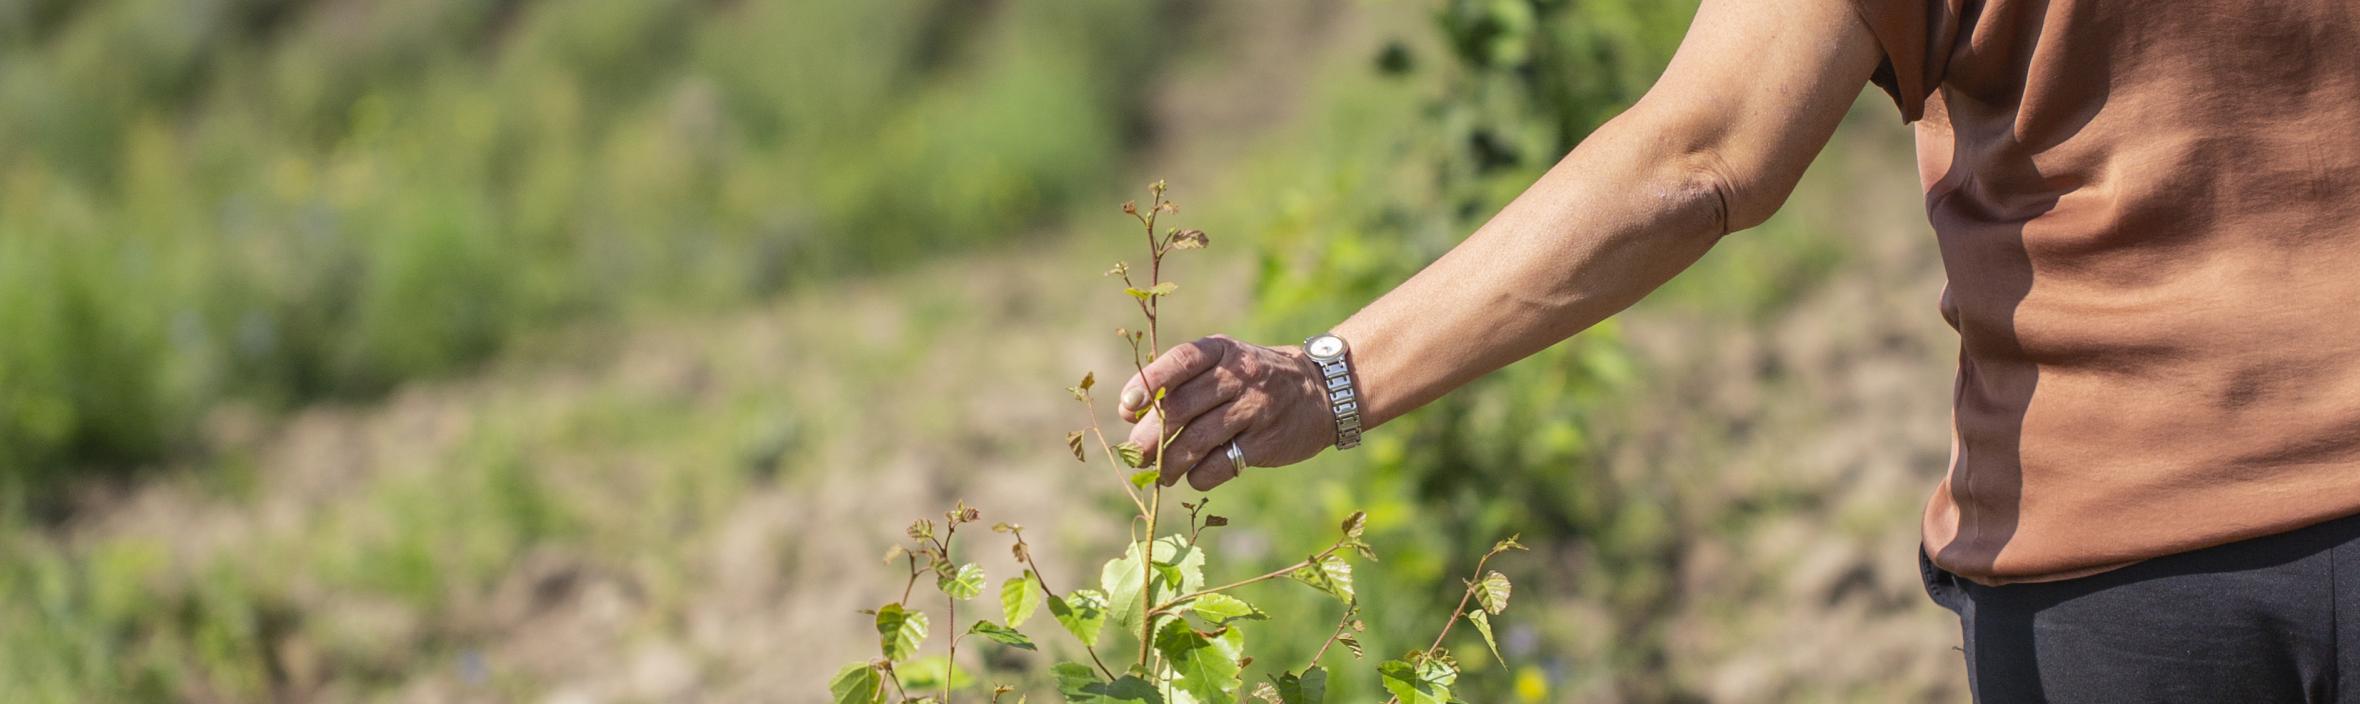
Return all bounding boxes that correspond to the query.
[1336,116,1730,428]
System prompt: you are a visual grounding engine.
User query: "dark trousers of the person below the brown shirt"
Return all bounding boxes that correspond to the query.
[1919,517,2360,704]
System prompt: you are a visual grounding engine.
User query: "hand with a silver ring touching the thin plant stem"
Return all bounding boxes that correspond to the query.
[1119,335,1336,491]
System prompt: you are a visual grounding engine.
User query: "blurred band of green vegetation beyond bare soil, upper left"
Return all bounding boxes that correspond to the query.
[0,0,1154,500]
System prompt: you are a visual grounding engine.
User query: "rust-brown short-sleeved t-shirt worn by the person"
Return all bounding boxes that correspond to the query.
[1855,0,2360,584]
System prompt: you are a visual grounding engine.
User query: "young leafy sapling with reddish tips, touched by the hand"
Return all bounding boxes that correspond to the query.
[828,182,1525,704]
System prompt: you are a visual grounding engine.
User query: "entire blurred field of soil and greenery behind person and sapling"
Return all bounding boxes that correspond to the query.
[0,0,1956,702]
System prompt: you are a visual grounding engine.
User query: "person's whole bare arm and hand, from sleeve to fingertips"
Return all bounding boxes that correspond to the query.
[1121,0,1883,489]
